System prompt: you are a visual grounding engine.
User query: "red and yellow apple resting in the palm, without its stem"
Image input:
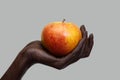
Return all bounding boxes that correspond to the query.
[41,22,82,57]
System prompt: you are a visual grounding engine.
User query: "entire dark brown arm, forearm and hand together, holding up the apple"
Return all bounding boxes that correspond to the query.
[0,25,94,80]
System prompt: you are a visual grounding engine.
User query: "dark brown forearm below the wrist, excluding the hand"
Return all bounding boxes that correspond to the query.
[1,54,31,80]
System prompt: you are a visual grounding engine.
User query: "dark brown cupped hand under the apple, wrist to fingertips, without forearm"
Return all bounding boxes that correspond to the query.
[24,25,93,69]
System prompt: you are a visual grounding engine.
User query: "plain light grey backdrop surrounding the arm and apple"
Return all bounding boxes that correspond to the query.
[0,0,120,80]
